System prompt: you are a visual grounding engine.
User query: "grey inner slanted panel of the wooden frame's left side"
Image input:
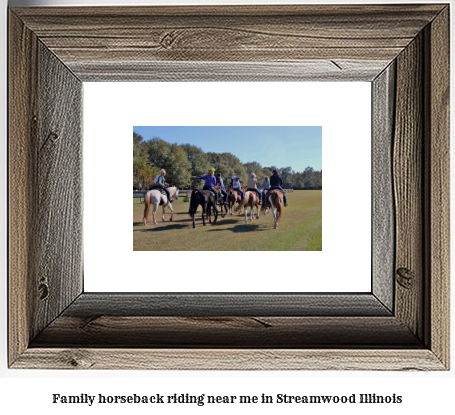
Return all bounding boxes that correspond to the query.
[31,43,83,337]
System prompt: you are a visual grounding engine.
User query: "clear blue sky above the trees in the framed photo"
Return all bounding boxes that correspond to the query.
[133,126,322,172]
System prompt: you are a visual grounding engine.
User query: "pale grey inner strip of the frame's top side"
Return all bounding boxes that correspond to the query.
[71,59,388,82]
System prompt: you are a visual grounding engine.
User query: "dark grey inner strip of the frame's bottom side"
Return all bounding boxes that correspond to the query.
[64,293,392,318]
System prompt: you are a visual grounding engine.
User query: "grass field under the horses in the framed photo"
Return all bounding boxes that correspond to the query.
[133,190,322,251]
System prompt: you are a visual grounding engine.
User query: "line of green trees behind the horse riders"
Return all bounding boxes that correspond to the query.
[133,132,322,190]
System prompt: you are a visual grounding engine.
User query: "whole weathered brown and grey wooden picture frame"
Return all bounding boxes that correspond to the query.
[8,4,449,370]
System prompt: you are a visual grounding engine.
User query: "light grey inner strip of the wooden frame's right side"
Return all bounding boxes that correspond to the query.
[371,62,396,310]
